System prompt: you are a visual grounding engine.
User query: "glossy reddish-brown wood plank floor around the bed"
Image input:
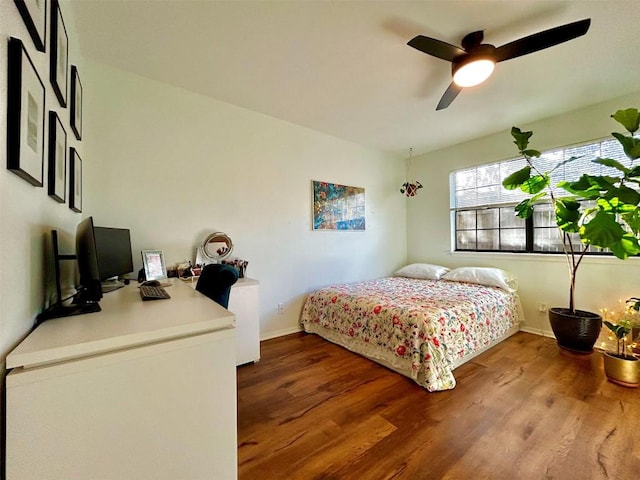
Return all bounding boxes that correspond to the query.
[238,332,640,480]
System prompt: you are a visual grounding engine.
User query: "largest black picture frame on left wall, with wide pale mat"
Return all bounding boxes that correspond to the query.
[7,38,45,187]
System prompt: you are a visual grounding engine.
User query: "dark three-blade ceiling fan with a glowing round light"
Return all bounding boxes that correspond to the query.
[407,18,591,110]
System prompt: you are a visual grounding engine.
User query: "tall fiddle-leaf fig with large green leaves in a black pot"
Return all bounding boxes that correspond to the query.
[502,108,640,353]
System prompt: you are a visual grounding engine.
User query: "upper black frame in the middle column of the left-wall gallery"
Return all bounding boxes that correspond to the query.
[49,0,69,107]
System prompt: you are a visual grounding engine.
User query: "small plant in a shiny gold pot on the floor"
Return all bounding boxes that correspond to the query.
[603,298,640,387]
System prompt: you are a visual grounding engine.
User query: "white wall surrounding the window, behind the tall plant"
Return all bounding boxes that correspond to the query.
[407,93,640,335]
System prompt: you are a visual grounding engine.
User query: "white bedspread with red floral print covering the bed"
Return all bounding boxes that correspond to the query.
[301,277,520,391]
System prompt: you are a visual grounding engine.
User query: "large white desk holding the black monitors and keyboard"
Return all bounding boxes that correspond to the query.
[6,281,237,480]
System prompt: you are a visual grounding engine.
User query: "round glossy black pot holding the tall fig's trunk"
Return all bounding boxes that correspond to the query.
[549,307,602,353]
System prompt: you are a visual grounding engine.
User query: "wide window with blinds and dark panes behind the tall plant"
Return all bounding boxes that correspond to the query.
[449,139,631,253]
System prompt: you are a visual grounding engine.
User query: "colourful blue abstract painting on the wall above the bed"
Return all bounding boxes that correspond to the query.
[313,180,365,231]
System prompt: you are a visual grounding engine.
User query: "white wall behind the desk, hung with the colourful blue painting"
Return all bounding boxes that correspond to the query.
[83,62,406,338]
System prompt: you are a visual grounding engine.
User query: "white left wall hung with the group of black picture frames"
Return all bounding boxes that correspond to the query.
[0,0,83,460]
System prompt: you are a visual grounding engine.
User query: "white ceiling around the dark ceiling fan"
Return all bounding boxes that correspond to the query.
[72,0,640,157]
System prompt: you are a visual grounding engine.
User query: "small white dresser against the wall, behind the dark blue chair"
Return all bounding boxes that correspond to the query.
[187,277,260,365]
